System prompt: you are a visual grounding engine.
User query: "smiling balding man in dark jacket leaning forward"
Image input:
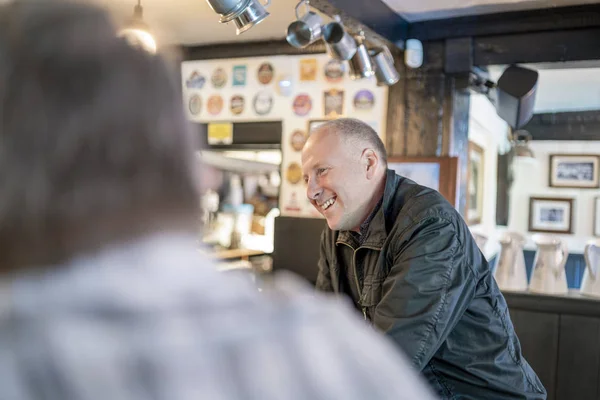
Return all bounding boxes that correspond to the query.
[302,119,546,399]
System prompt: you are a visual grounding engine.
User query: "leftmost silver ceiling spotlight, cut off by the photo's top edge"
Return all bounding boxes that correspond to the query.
[206,0,271,35]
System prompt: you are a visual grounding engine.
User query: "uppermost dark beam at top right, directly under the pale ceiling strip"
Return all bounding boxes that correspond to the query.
[408,4,600,41]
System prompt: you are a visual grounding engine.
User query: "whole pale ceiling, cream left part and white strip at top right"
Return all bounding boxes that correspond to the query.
[88,0,597,45]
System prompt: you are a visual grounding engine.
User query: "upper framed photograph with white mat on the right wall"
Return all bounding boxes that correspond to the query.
[548,154,600,189]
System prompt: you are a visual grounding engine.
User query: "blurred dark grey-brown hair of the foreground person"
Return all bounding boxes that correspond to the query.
[0,0,199,273]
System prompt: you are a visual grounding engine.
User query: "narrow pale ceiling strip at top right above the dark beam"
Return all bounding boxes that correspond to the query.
[382,0,598,22]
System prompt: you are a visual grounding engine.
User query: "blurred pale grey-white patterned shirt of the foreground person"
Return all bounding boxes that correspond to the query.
[0,235,432,400]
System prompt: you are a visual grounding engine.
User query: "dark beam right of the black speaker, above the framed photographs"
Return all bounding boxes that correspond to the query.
[523,110,600,140]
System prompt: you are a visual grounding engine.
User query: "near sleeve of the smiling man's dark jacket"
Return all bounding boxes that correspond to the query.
[372,217,477,370]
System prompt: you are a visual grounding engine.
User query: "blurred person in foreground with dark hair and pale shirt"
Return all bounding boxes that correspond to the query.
[0,0,430,400]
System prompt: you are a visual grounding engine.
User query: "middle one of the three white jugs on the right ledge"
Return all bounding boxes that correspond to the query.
[529,235,569,295]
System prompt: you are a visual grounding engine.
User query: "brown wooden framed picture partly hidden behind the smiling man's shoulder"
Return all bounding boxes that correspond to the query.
[388,156,458,207]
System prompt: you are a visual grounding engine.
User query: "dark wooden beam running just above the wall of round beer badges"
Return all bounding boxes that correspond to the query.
[183,40,326,61]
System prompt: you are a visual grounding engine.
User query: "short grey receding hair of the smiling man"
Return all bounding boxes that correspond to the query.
[313,118,387,166]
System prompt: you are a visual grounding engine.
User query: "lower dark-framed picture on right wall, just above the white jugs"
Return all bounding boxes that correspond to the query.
[529,197,574,233]
